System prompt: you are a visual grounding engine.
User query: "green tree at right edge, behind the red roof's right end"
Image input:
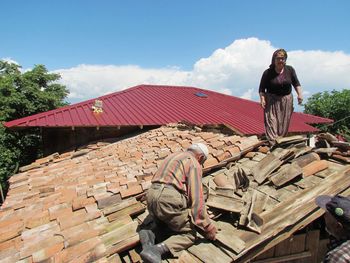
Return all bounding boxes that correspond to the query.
[304,89,350,141]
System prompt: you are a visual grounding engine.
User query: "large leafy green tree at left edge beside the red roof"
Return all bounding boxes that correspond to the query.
[0,60,69,198]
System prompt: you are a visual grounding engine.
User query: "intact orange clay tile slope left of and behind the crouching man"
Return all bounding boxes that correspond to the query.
[0,124,261,262]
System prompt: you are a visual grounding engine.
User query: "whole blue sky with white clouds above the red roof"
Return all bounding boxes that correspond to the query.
[0,0,350,109]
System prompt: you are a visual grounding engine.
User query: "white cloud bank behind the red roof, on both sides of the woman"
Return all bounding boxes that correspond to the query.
[55,38,350,105]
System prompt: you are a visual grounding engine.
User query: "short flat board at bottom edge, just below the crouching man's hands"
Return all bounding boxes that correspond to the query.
[187,242,232,263]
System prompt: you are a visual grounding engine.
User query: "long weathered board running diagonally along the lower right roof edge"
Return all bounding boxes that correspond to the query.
[232,166,350,261]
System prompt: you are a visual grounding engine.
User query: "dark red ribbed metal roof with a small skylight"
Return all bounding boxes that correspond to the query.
[5,85,332,135]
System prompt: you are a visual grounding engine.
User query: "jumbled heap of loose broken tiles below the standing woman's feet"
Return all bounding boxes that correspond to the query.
[204,136,348,236]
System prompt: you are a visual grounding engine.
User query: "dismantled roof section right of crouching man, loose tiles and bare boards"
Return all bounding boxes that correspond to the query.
[188,136,350,262]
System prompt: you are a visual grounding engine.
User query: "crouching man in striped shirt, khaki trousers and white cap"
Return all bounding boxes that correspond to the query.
[139,143,217,262]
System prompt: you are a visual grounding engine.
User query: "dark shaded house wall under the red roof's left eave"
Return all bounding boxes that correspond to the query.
[42,126,158,156]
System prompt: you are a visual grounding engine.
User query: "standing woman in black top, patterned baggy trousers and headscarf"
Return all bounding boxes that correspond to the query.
[259,49,303,145]
